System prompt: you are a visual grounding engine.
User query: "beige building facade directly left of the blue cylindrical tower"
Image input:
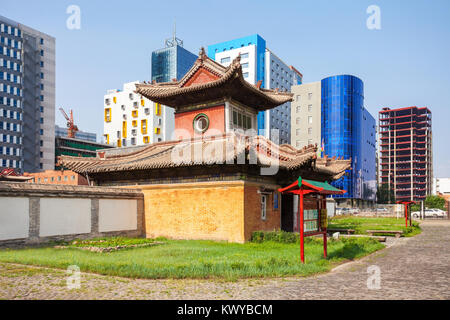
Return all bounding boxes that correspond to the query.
[291,81,322,152]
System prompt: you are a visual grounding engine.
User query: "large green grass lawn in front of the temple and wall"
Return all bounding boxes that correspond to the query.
[0,238,384,280]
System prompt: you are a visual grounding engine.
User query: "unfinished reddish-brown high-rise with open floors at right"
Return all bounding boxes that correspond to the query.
[378,107,433,201]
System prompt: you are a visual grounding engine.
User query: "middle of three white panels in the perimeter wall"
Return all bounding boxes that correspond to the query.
[39,198,91,237]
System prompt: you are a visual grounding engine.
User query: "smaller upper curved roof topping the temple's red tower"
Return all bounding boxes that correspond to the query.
[136,48,293,111]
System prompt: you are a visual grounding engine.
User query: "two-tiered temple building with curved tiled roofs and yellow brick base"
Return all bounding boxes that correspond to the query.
[59,49,350,242]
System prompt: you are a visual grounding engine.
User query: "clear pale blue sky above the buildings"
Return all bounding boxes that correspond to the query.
[0,0,450,177]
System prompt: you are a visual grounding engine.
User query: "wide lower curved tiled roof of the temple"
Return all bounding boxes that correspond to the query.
[58,133,351,179]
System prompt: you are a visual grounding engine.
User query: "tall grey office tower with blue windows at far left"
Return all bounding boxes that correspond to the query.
[0,16,55,173]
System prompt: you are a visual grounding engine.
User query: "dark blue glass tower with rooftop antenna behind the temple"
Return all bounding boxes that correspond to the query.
[151,33,197,82]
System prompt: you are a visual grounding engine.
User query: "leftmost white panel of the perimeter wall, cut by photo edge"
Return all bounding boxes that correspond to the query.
[0,197,30,240]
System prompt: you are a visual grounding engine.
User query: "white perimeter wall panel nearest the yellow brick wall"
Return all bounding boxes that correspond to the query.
[98,199,137,232]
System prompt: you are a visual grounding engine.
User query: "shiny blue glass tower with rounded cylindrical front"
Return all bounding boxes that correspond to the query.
[321,75,376,201]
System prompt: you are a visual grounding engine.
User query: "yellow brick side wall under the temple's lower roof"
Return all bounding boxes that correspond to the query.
[139,181,247,242]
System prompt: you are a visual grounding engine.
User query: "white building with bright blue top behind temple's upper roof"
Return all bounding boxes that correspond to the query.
[208,34,303,144]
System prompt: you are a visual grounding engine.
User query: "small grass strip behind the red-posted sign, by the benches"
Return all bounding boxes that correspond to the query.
[328,216,421,237]
